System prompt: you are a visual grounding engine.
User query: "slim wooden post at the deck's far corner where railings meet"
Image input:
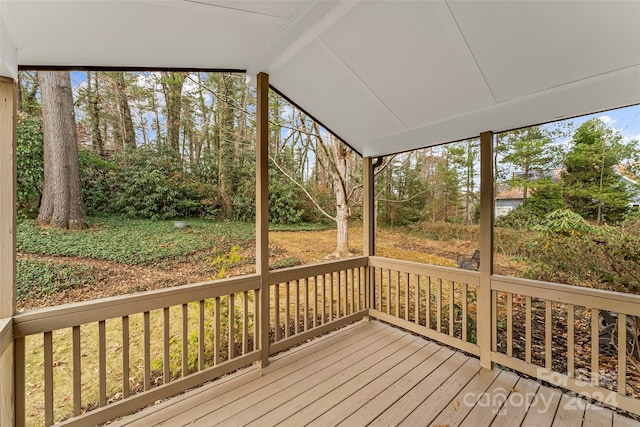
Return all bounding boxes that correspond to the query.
[362,157,376,314]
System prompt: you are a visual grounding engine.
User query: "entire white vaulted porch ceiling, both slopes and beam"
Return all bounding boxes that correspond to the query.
[0,0,640,156]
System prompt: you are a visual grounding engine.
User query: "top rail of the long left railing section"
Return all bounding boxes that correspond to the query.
[13,274,260,338]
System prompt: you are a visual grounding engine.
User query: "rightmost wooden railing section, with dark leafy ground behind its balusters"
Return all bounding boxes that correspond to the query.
[491,276,640,414]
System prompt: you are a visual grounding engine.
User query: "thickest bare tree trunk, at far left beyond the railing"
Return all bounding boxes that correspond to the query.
[36,71,86,229]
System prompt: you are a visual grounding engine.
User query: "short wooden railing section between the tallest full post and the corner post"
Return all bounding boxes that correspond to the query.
[269,257,367,354]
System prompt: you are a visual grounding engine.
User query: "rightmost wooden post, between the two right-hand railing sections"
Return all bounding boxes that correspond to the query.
[478,132,495,369]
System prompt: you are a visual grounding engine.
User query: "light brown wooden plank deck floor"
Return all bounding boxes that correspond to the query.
[112,321,640,427]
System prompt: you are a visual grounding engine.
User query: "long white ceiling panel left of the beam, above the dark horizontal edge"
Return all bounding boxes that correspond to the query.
[10,1,285,69]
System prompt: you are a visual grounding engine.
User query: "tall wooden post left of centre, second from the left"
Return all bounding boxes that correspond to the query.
[256,73,269,367]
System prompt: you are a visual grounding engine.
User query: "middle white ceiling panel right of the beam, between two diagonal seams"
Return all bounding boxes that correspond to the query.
[322,2,493,127]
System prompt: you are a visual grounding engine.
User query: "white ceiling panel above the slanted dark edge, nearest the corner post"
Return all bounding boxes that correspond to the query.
[270,42,402,152]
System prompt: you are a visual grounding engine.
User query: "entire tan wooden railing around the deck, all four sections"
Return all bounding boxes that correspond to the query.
[10,257,640,426]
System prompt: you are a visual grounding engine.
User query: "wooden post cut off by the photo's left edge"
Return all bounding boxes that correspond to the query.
[0,76,17,426]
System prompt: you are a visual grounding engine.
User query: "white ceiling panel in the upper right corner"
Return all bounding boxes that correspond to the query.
[448,1,640,101]
